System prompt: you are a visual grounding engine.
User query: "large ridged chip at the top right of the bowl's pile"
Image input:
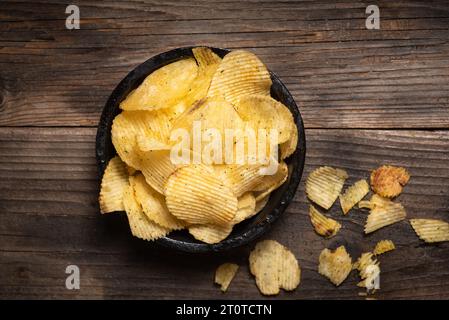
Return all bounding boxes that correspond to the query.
[207,50,271,104]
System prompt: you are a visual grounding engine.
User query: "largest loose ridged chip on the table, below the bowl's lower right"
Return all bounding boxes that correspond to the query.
[249,240,301,295]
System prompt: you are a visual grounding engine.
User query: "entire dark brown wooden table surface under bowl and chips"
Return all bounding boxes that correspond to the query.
[0,0,449,299]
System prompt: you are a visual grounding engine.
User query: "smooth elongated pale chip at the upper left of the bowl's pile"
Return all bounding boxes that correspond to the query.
[120,58,198,110]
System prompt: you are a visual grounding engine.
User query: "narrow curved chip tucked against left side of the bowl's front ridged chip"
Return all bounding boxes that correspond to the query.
[130,174,185,230]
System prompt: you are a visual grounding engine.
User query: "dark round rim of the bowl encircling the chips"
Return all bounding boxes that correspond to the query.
[95,46,306,253]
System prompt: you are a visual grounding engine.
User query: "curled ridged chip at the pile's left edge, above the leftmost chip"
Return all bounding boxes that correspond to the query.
[111,111,170,170]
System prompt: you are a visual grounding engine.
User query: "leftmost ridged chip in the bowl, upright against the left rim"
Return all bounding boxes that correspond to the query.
[98,156,128,213]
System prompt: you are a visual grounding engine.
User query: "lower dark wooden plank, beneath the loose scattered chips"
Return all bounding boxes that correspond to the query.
[0,128,449,299]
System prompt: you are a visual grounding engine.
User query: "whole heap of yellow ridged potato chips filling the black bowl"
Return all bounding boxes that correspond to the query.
[99,47,298,244]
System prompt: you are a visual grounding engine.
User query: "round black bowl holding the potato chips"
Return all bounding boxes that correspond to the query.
[96,47,306,252]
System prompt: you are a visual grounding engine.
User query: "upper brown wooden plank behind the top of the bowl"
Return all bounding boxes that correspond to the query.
[0,1,449,128]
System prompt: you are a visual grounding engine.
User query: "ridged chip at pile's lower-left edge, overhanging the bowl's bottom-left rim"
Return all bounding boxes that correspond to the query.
[123,185,170,240]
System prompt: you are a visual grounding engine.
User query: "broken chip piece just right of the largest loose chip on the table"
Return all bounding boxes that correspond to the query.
[318,246,352,286]
